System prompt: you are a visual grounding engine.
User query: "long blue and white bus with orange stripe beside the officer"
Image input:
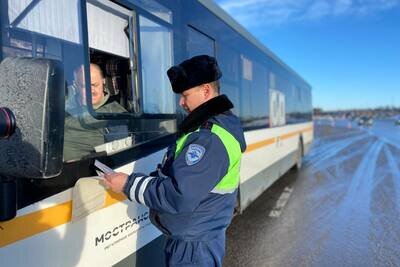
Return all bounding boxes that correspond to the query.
[0,0,313,267]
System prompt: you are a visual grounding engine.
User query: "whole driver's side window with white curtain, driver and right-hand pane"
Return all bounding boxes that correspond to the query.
[64,0,176,161]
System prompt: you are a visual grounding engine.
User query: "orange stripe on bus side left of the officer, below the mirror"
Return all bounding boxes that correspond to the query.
[0,191,126,248]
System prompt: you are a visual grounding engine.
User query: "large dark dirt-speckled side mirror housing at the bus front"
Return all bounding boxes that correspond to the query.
[0,57,65,178]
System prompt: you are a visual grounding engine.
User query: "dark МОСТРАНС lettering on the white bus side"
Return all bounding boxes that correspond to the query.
[94,211,149,247]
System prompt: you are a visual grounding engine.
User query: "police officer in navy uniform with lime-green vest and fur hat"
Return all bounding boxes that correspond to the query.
[104,55,246,267]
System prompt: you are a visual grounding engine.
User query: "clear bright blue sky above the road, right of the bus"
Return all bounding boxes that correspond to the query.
[214,0,400,110]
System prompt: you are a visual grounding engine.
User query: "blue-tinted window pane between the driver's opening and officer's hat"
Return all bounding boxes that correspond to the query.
[135,12,176,142]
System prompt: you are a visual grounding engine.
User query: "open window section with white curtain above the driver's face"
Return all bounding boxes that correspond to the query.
[86,1,135,113]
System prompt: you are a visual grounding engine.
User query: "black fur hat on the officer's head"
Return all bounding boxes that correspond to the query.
[167,55,222,94]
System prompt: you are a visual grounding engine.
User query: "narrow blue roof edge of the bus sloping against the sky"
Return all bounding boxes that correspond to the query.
[198,0,311,88]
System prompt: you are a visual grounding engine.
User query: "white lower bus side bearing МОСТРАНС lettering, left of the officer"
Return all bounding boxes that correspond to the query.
[0,150,165,266]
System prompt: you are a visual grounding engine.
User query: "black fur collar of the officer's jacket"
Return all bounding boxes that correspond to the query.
[178,95,233,137]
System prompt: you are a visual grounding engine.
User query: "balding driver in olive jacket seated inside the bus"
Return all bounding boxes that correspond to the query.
[64,62,133,161]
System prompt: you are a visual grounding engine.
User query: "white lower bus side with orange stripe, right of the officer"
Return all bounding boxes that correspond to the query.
[239,123,313,211]
